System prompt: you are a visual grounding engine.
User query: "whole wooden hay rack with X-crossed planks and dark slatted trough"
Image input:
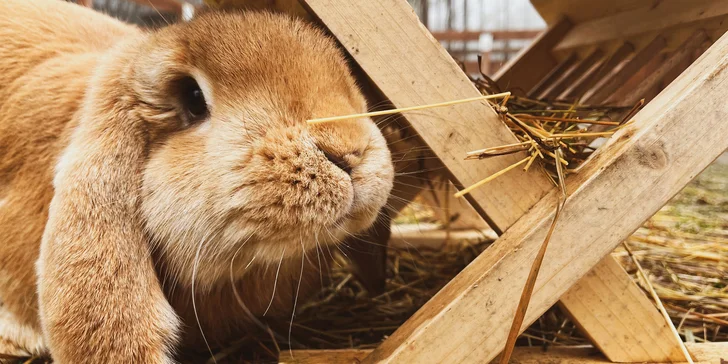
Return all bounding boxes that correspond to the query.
[219,0,728,363]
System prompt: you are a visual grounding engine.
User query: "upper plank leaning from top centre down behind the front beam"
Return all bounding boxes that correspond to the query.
[296,0,688,362]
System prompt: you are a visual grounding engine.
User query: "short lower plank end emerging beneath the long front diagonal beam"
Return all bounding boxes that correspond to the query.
[561,255,684,363]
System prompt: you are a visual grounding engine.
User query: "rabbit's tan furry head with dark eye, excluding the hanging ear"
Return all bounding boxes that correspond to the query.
[52,13,394,287]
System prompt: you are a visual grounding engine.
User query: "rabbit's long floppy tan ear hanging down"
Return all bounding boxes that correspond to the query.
[38,50,179,363]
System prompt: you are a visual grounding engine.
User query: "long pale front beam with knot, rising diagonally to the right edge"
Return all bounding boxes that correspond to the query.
[364,29,728,363]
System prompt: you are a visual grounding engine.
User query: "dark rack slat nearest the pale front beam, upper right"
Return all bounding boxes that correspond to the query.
[610,30,708,105]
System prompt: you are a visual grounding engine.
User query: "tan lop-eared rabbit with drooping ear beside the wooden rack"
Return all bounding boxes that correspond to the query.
[0,0,394,364]
